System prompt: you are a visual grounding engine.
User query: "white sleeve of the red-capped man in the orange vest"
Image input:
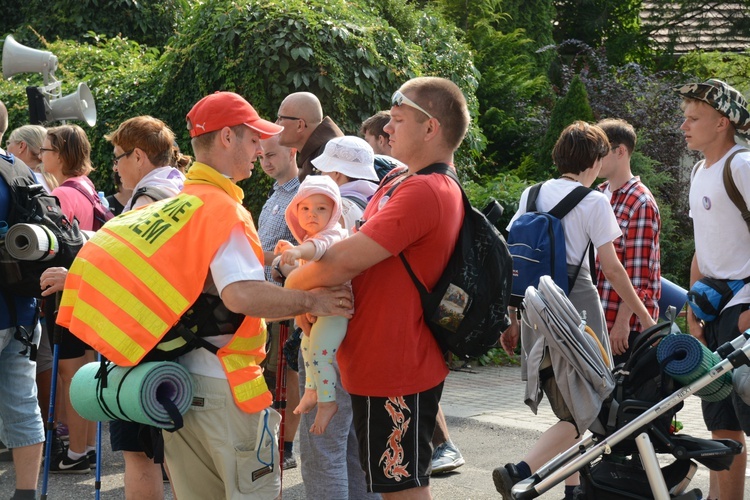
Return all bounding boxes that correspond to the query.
[211,224,266,295]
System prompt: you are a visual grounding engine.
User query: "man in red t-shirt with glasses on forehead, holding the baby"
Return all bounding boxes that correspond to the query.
[286,77,470,499]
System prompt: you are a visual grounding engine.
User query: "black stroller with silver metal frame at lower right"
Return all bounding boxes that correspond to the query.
[512,277,750,500]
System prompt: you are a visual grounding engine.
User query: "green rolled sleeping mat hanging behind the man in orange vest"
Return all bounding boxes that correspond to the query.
[70,361,193,430]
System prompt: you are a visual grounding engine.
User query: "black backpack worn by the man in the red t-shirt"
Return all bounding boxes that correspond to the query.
[386,163,513,359]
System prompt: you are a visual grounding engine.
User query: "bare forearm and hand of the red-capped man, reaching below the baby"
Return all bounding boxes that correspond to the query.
[221,281,354,318]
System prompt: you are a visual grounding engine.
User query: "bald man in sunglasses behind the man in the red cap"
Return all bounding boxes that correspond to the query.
[276,92,344,181]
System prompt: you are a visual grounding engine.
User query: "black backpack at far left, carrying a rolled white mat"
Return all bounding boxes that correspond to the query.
[0,158,86,297]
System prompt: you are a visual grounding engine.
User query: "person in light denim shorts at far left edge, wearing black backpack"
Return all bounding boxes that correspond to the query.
[0,98,44,500]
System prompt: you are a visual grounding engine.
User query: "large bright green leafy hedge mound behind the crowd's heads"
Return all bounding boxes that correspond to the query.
[0,0,484,214]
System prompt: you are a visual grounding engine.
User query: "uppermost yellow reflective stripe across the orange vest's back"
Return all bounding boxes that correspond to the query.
[89,231,190,317]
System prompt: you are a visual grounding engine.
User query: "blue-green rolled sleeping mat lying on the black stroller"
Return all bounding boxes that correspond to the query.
[656,334,732,401]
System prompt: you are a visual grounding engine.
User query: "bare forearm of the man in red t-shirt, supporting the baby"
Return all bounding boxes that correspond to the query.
[285,232,391,290]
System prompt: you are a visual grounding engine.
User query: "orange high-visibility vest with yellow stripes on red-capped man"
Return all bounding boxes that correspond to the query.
[57,180,272,413]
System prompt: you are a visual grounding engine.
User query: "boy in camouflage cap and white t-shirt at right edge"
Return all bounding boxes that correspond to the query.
[674,79,750,500]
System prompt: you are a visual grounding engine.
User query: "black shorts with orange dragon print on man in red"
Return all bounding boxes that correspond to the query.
[351,382,443,493]
